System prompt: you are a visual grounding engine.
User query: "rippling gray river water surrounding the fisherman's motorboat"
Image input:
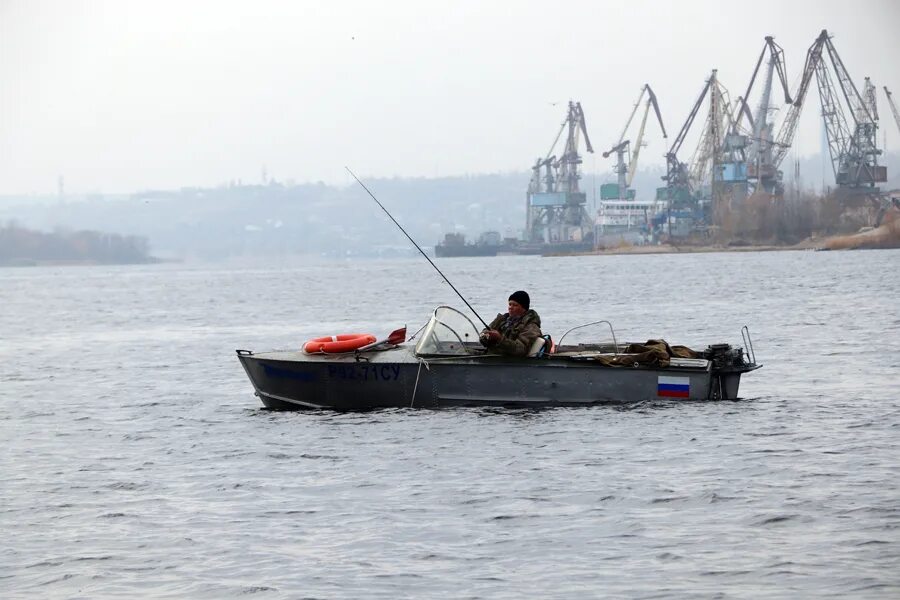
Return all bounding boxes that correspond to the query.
[0,251,900,598]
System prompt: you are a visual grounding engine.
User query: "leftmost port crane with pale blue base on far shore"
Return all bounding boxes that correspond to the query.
[526,101,594,242]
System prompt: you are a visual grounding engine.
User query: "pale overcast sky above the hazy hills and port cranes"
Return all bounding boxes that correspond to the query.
[0,0,900,194]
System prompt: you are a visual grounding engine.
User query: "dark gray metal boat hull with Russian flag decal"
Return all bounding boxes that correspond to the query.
[238,348,755,410]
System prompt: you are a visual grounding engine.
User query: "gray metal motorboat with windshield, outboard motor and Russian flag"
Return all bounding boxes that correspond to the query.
[236,306,761,410]
